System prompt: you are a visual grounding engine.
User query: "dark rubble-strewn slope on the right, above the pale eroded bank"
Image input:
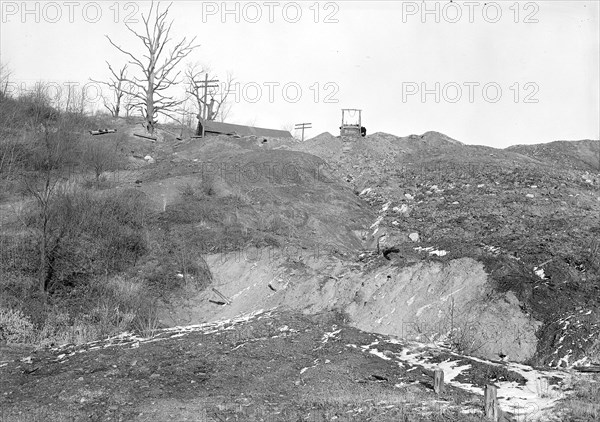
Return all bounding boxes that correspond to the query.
[274,132,600,365]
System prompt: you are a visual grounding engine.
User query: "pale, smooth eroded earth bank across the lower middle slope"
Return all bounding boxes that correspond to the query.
[163,250,541,362]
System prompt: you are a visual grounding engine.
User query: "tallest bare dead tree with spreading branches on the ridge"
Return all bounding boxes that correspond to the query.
[106,2,199,134]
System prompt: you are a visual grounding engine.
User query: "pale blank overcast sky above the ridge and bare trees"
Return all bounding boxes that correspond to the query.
[0,0,600,148]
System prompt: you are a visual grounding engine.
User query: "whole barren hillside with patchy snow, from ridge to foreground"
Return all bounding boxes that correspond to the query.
[0,110,600,421]
